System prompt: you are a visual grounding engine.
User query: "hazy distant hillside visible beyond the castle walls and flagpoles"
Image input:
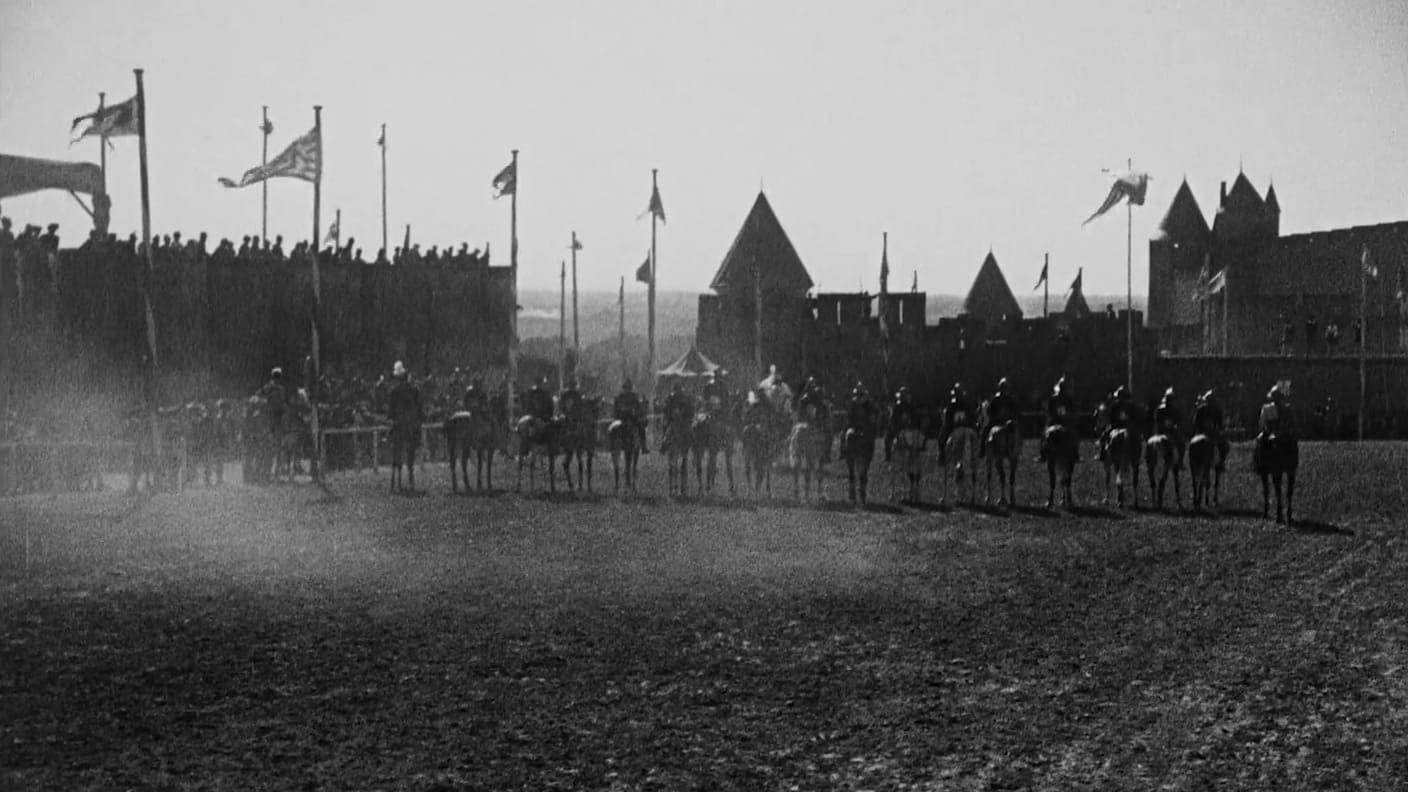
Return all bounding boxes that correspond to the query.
[518,286,1145,347]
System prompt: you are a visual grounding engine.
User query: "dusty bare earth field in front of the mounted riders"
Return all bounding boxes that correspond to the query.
[0,444,1408,791]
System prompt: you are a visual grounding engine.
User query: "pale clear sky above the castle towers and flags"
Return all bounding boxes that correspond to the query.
[0,0,1408,295]
